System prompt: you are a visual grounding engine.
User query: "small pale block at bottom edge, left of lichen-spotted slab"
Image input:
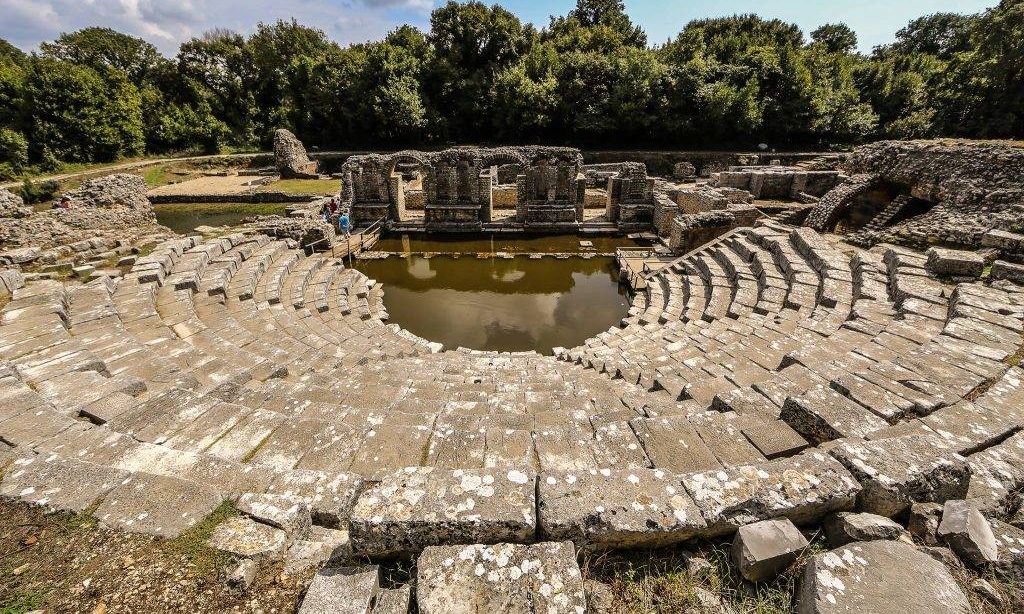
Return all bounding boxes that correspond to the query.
[299,566,380,614]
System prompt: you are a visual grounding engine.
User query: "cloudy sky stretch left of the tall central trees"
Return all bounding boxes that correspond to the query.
[0,0,436,55]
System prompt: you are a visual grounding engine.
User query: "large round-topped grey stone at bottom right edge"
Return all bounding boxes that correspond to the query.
[797,540,973,614]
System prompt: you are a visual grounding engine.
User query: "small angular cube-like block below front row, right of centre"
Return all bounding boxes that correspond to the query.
[732,518,810,582]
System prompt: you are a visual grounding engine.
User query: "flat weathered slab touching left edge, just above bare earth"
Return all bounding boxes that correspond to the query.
[0,454,131,513]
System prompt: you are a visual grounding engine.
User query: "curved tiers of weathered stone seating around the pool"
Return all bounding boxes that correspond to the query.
[0,223,1024,581]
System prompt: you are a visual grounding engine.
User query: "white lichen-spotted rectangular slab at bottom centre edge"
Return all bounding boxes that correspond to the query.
[416,541,587,614]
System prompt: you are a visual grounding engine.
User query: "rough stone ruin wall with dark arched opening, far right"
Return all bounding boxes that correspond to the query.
[807,140,1024,248]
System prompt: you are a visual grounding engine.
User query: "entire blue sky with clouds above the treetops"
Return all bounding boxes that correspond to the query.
[0,0,997,54]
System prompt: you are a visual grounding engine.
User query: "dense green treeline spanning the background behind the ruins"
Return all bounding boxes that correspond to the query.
[0,0,1024,176]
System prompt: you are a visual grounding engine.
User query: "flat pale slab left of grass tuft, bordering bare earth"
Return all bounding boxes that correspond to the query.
[93,473,223,539]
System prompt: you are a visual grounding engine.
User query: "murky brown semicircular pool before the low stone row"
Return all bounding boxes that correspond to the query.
[357,255,629,353]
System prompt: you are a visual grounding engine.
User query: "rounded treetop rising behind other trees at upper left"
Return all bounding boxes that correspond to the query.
[40,28,164,86]
